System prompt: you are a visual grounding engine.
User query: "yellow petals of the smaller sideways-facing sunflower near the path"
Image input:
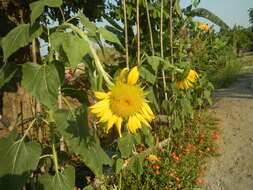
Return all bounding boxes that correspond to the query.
[176,69,199,89]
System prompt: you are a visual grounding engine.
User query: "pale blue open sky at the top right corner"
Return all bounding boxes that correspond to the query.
[181,0,253,27]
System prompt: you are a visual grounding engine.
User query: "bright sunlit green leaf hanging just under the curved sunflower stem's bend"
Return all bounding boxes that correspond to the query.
[50,32,89,68]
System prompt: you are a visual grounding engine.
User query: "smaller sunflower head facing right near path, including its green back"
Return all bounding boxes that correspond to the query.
[176,69,199,89]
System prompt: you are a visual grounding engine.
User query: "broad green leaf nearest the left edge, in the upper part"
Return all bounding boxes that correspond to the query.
[2,24,43,62]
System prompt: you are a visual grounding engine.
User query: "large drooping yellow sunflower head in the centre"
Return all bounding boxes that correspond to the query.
[90,67,154,137]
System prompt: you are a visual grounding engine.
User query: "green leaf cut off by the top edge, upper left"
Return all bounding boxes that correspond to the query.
[30,0,62,24]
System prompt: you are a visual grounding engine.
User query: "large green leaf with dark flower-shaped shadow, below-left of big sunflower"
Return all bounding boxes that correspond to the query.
[53,108,112,176]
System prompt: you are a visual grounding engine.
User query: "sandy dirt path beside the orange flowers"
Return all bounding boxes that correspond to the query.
[202,74,253,190]
